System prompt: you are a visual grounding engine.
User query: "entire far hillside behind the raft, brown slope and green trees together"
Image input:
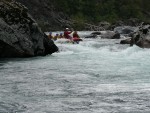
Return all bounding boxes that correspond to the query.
[17,0,150,31]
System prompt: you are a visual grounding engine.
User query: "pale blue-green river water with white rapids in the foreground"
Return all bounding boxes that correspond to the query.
[0,32,150,113]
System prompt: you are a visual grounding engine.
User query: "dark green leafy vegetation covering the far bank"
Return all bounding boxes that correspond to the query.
[52,0,150,23]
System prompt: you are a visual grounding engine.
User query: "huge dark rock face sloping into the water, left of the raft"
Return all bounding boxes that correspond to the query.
[0,0,58,57]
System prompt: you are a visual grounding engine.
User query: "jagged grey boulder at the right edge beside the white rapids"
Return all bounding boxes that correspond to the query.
[130,25,150,48]
